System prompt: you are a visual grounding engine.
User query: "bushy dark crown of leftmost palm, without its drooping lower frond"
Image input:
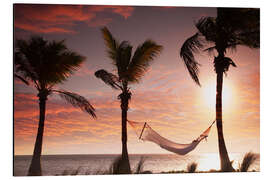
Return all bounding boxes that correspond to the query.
[15,36,85,88]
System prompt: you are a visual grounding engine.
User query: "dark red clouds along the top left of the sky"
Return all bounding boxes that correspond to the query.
[14,4,134,33]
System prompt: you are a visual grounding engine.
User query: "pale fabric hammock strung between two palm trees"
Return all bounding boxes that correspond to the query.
[128,120,215,155]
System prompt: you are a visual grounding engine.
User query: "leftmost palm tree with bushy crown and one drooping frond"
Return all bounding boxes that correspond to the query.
[14,37,96,176]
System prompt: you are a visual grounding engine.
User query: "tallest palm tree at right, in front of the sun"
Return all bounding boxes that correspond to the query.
[180,8,260,171]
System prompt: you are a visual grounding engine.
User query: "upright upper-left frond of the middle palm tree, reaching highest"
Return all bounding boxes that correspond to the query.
[101,27,119,65]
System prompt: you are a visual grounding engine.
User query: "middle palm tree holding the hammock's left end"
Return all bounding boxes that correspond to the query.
[95,27,162,173]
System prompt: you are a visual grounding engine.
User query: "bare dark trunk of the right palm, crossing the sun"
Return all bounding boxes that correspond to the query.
[216,71,233,172]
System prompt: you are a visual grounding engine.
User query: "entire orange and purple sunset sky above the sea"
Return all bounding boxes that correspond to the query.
[14,5,260,155]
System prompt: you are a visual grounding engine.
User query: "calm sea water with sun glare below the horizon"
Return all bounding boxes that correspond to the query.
[14,153,260,176]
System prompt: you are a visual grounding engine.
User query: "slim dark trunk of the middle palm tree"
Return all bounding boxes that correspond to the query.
[120,86,131,174]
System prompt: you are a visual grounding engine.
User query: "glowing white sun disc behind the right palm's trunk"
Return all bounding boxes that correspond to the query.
[203,82,233,110]
